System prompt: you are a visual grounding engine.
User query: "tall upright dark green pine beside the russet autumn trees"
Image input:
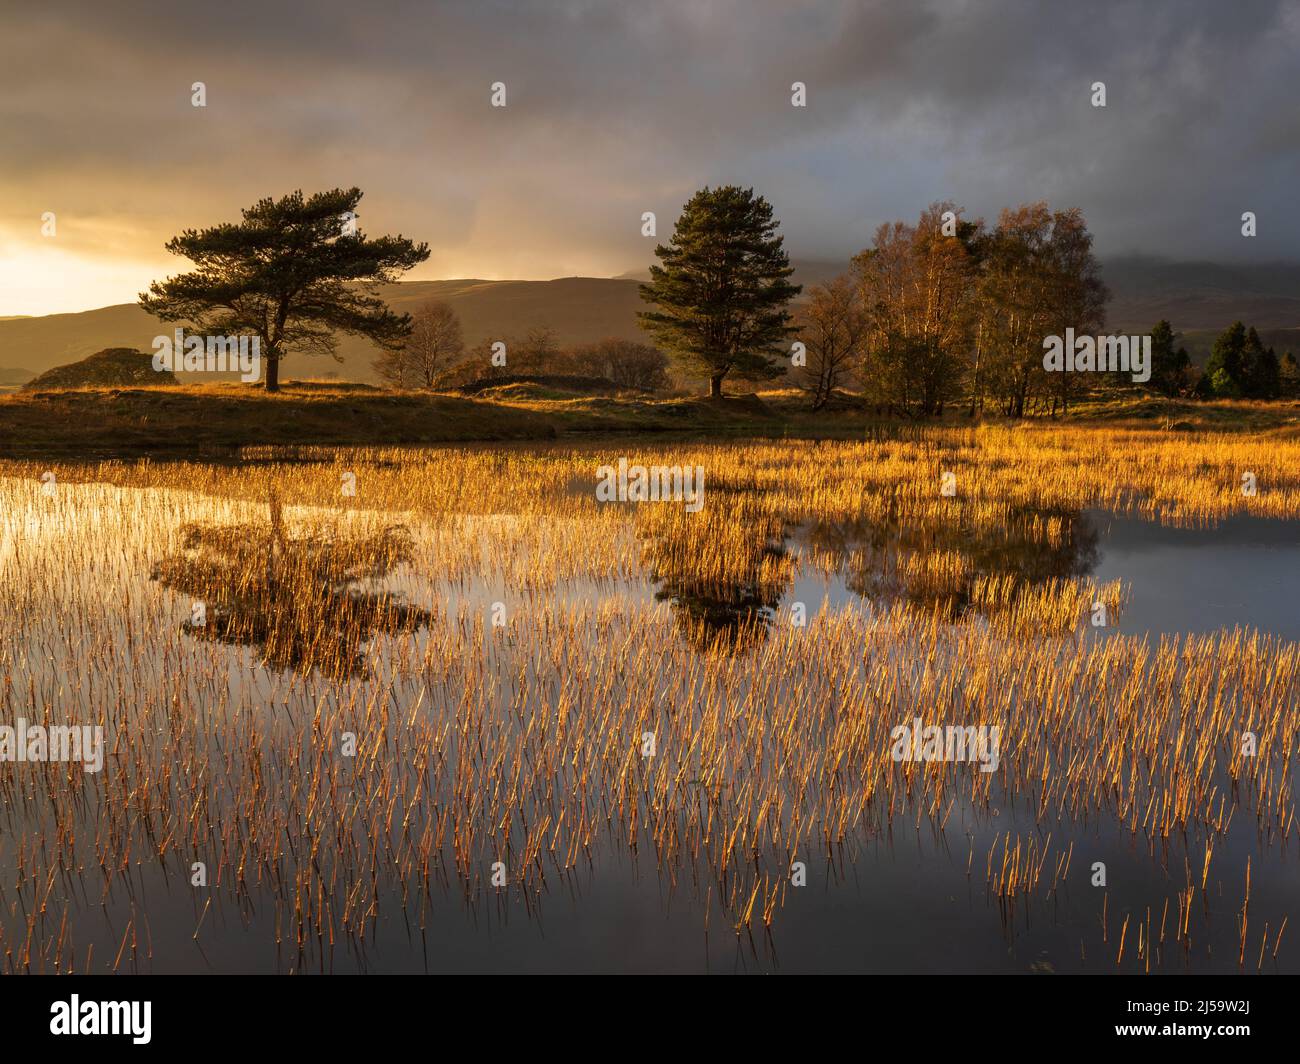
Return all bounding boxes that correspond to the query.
[637,185,800,397]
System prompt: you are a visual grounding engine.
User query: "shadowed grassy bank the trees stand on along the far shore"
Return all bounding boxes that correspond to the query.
[0,381,1300,457]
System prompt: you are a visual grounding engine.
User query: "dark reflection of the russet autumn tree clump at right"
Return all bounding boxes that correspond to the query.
[807,507,1100,619]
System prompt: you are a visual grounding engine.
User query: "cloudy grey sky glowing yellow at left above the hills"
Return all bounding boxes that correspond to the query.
[0,0,1300,316]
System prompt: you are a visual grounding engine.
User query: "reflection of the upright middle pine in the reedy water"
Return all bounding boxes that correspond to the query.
[640,494,792,653]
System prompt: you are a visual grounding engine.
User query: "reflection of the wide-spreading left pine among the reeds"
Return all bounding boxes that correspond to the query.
[152,497,432,679]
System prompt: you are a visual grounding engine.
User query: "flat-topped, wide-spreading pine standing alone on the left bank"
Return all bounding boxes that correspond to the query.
[139,189,429,392]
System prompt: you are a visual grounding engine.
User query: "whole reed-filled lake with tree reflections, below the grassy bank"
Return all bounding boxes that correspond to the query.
[0,441,1300,973]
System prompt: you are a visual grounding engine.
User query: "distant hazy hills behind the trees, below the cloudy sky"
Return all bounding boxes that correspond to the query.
[0,256,1300,381]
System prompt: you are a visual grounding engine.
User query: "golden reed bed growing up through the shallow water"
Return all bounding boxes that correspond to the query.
[0,418,1300,972]
